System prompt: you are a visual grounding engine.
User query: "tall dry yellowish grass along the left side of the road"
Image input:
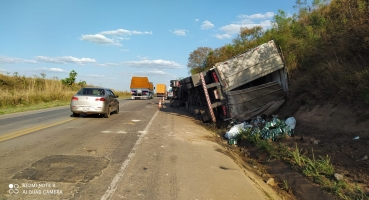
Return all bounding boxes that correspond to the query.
[0,74,131,115]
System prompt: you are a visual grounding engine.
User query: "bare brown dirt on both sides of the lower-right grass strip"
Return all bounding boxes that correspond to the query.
[222,105,369,199]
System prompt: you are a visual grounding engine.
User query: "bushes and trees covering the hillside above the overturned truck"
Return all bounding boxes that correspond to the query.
[187,0,369,105]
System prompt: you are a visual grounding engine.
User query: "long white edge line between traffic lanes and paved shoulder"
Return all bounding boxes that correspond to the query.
[101,110,159,200]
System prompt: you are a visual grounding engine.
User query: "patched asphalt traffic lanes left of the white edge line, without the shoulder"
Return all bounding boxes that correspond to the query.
[0,100,158,199]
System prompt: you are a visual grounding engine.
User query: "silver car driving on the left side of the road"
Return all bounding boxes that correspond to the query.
[70,87,119,118]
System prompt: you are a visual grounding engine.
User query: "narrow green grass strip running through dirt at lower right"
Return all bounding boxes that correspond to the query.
[231,130,369,199]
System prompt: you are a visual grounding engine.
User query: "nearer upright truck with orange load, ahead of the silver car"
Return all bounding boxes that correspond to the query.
[130,76,154,100]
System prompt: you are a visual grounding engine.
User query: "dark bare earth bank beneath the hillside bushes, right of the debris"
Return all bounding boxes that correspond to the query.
[291,105,369,192]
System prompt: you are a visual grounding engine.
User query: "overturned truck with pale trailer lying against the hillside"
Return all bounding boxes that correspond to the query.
[173,40,288,122]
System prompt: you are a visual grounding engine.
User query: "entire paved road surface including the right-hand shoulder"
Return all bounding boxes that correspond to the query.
[0,99,278,199]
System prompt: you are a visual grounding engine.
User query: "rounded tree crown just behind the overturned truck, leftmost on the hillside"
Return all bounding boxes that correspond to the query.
[187,47,212,74]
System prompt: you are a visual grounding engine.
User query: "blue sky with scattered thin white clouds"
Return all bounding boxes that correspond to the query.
[0,0,296,91]
